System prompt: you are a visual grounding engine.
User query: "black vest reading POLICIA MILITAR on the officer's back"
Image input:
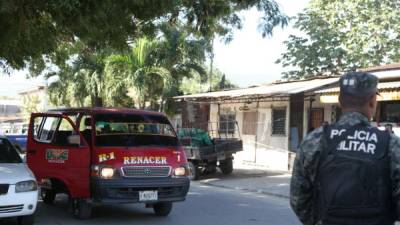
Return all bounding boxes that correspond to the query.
[314,125,394,225]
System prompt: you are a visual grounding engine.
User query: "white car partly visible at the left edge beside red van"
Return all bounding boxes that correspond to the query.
[0,136,38,225]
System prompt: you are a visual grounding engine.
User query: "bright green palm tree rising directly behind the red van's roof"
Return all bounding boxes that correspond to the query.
[106,38,171,109]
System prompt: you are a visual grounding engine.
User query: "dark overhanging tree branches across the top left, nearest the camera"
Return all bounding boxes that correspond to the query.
[0,0,287,73]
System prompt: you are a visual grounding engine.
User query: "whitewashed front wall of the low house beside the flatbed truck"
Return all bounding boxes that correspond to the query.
[210,101,290,170]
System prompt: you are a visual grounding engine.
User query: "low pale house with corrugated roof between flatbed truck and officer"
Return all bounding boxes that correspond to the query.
[175,77,339,170]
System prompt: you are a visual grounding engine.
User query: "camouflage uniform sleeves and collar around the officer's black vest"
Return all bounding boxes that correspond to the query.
[290,112,400,225]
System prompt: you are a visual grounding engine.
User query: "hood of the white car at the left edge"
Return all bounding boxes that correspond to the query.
[0,163,35,184]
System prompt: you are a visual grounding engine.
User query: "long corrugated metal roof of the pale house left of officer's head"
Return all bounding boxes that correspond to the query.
[174,77,339,99]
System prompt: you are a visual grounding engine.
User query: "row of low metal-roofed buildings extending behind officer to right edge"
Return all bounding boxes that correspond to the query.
[175,63,400,170]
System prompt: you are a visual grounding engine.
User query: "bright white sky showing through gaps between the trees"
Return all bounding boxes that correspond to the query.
[0,0,309,96]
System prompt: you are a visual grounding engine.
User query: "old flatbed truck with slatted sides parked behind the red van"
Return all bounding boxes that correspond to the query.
[178,121,243,180]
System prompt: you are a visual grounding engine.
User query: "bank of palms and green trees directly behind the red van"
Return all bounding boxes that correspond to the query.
[46,25,207,111]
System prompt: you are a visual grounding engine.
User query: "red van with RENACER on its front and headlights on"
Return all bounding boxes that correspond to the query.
[27,108,190,219]
